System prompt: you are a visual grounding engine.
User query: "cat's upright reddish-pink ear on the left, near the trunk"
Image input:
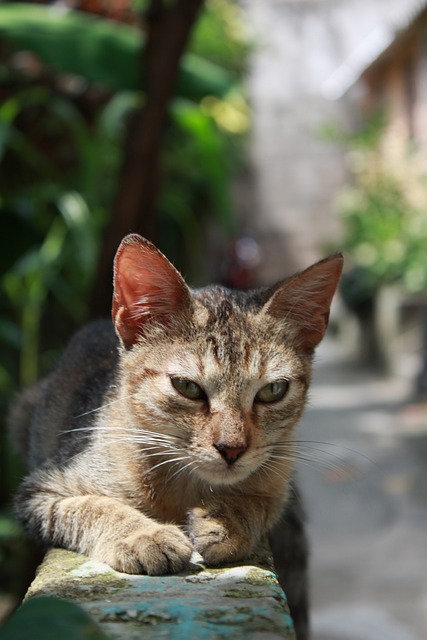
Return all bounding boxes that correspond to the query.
[112,234,191,349]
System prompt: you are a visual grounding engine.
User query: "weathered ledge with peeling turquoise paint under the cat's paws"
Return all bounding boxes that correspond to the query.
[26,549,295,640]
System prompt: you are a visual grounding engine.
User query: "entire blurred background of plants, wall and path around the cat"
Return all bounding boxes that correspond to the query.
[0,0,427,640]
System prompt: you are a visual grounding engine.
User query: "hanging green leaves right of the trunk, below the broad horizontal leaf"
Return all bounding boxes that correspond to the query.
[157,99,239,284]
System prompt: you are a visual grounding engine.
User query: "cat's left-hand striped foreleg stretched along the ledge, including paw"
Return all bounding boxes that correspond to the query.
[15,469,192,575]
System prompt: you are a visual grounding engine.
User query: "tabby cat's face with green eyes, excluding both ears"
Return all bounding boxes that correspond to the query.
[120,303,310,485]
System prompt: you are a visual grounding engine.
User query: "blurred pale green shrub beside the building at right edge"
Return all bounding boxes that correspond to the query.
[339,116,427,300]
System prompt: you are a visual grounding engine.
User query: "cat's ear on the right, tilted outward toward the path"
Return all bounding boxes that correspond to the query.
[264,253,343,351]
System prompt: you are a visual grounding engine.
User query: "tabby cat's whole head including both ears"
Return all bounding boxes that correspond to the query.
[112,235,342,484]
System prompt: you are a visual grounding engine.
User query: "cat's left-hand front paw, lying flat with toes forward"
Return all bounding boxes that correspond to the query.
[100,525,193,576]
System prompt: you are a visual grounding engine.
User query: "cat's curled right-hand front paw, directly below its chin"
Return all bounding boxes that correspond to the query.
[188,507,253,565]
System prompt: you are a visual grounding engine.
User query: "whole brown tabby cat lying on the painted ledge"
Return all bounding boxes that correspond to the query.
[10,234,342,639]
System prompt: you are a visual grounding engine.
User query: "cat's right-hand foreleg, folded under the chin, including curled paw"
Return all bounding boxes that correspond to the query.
[188,495,281,565]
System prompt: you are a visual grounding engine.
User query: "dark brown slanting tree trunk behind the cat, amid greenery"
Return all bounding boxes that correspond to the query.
[91,0,203,316]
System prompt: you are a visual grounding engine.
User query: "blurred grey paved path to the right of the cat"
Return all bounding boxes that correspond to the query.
[298,340,427,640]
